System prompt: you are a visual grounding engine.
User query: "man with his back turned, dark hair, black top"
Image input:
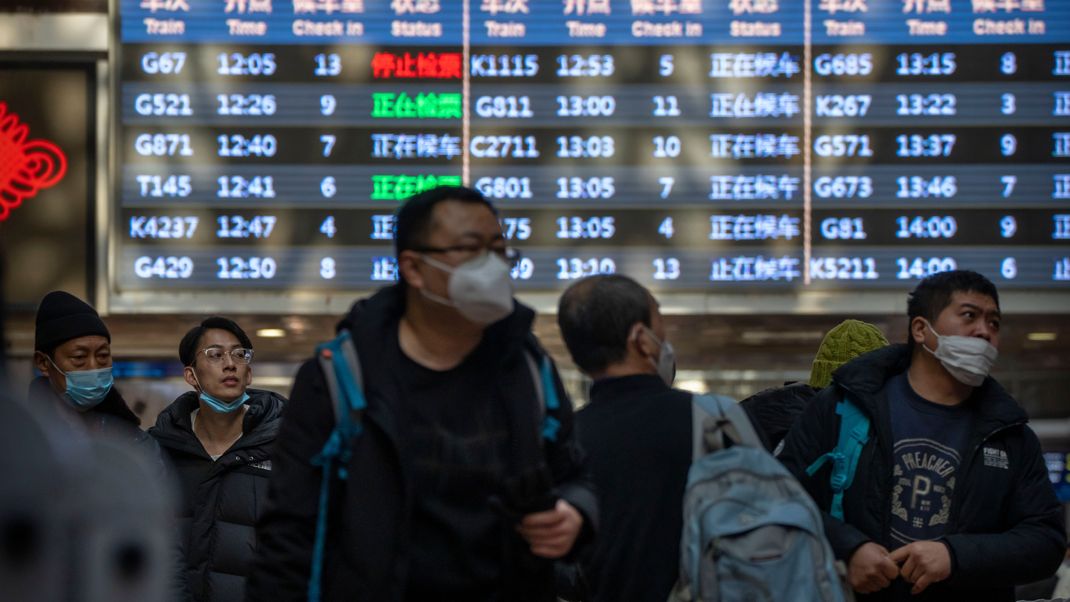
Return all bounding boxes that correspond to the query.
[557,275,691,602]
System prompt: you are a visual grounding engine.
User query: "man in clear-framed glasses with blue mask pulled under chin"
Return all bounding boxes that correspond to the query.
[149,318,286,602]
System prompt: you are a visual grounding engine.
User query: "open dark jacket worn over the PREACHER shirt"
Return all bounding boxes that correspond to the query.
[780,345,1066,602]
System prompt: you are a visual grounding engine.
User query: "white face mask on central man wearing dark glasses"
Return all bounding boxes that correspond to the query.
[419,252,513,326]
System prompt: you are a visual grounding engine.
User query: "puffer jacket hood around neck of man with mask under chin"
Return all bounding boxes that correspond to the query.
[149,388,286,454]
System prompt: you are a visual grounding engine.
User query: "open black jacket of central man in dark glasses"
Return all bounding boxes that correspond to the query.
[246,287,596,602]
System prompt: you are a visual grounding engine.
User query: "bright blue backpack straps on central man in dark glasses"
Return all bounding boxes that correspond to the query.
[308,330,561,602]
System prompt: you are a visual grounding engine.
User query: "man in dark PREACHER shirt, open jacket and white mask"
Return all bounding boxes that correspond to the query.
[780,271,1066,602]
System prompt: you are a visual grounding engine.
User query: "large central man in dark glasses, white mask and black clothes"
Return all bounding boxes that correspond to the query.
[246,187,596,602]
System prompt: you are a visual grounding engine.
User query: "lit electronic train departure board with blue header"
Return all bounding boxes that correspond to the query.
[112,0,1070,292]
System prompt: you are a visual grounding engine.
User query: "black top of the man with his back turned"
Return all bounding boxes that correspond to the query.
[576,374,691,602]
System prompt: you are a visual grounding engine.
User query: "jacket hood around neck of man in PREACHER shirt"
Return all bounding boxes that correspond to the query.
[832,344,1027,431]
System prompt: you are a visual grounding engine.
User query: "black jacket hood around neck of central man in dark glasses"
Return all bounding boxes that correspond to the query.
[337,284,535,371]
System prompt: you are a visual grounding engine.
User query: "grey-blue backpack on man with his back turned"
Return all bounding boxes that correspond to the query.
[670,396,854,602]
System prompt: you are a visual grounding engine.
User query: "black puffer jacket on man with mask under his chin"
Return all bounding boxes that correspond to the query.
[149,389,286,602]
